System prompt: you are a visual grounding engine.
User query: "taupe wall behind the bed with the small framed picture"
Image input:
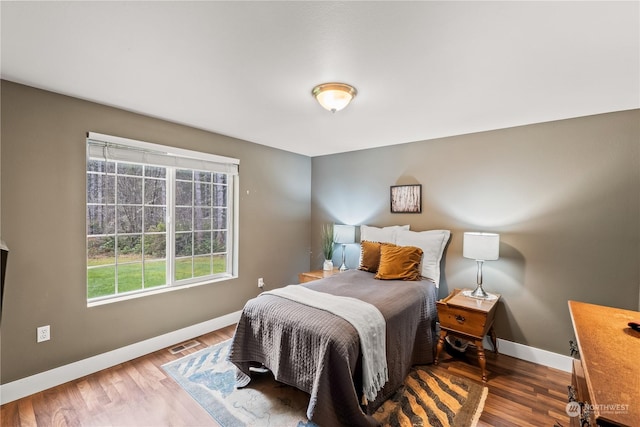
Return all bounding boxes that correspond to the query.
[311,110,640,354]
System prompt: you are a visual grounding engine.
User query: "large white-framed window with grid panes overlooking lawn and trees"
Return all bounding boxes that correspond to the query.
[86,133,239,304]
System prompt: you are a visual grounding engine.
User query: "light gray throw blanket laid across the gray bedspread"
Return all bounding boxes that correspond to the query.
[262,285,389,401]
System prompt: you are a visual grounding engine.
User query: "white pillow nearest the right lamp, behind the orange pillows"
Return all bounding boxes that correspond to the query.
[396,230,451,286]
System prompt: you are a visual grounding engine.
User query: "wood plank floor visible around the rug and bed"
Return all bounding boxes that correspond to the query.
[0,326,571,427]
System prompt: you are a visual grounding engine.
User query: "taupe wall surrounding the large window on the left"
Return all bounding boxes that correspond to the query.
[0,81,311,384]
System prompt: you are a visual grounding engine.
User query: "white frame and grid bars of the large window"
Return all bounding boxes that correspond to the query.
[85,132,240,307]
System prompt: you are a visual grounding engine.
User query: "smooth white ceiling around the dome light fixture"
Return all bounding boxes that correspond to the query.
[0,1,640,156]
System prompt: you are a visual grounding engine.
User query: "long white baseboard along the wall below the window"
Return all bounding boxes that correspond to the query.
[0,311,241,405]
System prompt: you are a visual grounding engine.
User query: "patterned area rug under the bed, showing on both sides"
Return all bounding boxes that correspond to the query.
[162,341,487,427]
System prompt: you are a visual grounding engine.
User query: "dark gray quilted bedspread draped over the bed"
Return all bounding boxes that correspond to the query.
[230,270,438,426]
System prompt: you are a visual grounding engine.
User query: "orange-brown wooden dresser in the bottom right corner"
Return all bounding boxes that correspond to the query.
[567,301,640,427]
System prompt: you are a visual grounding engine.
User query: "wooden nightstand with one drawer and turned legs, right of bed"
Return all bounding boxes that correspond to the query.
[434,289,500,382]
